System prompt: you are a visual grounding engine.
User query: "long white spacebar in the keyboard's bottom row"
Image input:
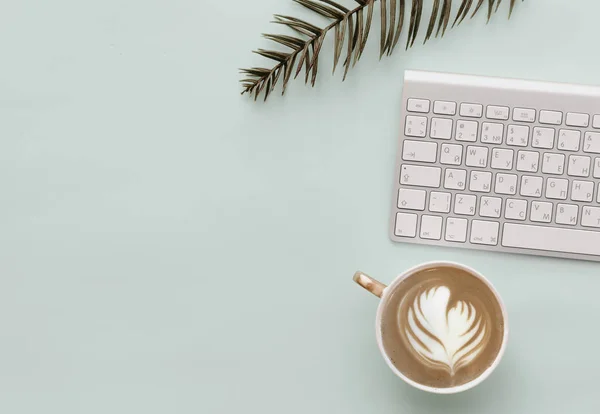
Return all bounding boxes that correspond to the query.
[502,223,600,256]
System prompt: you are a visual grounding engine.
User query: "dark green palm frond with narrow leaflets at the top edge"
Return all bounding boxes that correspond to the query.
[240,0,524,100]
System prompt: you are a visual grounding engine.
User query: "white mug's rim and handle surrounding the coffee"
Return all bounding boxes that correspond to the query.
[354,262,508,394]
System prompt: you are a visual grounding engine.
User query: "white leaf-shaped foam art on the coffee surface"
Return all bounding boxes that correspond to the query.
[403,286,488,375]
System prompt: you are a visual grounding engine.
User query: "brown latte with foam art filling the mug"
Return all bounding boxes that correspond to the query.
[381,266,505,388]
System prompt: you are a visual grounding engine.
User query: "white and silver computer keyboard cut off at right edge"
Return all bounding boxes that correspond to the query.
[390,71,600,261]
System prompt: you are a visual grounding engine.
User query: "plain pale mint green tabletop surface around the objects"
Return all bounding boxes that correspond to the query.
[0,0,600,414]
